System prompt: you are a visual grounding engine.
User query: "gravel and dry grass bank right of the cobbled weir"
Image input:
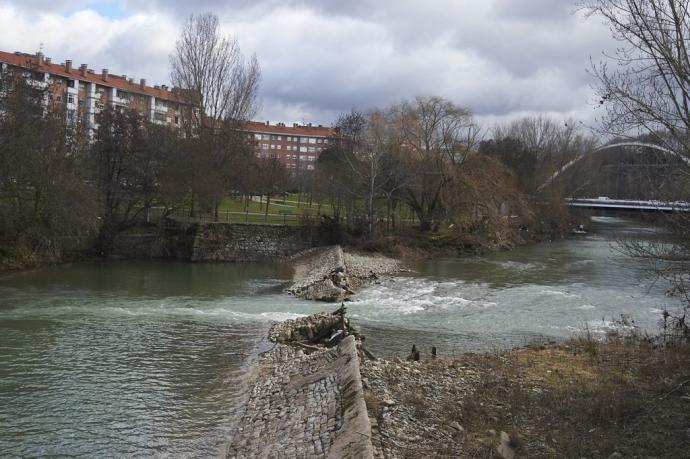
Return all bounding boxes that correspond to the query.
[362,335,690,458]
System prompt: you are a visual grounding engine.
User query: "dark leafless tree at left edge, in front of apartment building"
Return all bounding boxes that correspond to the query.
[0,70,95,269]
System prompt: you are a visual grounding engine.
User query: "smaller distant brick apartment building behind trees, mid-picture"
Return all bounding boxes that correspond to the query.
[243,121,337,172]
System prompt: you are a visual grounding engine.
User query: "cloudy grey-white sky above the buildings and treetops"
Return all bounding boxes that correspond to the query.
[0,0,614,126]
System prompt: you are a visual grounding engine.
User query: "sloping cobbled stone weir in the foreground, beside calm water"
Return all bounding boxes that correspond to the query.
[227,336,373,459]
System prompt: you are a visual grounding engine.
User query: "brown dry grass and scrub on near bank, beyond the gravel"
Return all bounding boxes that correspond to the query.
[454,336,690,458]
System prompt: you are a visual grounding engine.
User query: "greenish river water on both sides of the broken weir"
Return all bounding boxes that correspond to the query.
[0,218,677,457]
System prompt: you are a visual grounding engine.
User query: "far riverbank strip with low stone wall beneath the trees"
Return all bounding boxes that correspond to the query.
[0,200,581,273]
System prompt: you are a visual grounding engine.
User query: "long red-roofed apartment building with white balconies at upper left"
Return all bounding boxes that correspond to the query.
[0,51,187,129]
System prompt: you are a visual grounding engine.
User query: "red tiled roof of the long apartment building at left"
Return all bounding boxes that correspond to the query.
[0,51,184,102]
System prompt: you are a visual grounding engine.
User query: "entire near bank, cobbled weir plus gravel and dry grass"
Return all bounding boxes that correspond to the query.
[229,311,690,459]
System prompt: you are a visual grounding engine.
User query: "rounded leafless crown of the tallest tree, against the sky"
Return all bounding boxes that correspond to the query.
[170,13,261,128]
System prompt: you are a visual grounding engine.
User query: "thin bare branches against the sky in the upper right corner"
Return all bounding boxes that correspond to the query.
[583,0,690,161]
